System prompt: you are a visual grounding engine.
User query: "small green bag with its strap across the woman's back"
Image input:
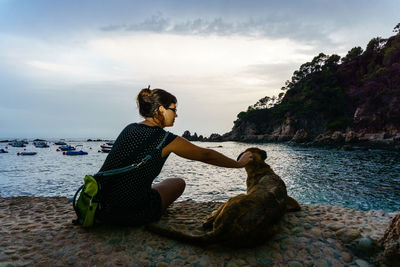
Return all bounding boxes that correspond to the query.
[72,132,169,227]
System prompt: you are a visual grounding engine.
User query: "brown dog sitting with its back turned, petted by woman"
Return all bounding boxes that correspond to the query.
[148,148,301,247]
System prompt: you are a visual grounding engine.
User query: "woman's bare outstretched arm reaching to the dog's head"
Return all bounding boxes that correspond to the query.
[162,136,252,168]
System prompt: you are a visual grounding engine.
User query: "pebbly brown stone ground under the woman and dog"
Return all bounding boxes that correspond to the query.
[0,197,395,267]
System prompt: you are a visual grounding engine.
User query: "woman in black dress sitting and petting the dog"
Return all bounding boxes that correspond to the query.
[96,88,252,225]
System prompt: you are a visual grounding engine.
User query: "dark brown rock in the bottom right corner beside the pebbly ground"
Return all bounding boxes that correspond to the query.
[379,213,400,266]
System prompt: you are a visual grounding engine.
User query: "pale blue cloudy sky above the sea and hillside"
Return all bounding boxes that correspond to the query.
[0,0,400,139]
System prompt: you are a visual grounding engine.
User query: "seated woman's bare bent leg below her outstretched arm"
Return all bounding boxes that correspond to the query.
[152,178,186,211]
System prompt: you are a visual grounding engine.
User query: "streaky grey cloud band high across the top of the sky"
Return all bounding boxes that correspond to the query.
[100,13,332,43]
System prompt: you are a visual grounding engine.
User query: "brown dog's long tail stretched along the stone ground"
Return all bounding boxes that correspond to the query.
[146,223,218,245]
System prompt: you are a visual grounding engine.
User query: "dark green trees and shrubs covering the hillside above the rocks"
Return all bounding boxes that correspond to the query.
[235,23,400,136]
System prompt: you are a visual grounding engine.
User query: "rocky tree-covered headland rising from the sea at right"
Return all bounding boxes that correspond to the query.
[191,23,400,149]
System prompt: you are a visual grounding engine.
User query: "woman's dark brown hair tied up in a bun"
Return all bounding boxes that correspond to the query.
[136,86,177,123]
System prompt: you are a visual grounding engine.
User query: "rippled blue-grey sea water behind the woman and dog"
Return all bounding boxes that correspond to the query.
[0,142,400,211]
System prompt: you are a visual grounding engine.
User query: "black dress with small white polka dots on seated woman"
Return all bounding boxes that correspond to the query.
[96,123,176,225]
